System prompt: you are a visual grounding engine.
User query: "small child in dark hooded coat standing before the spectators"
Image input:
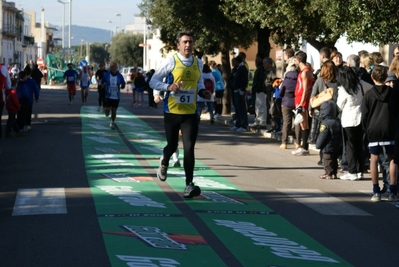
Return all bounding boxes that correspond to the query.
[316,100,342,179]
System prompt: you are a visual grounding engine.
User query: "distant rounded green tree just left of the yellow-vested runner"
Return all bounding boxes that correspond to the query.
[108,33,144,66]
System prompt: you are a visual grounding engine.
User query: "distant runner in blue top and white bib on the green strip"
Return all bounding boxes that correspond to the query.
[101,62,126,130]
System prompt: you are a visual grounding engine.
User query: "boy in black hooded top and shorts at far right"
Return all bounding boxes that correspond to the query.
[361,65,397,202]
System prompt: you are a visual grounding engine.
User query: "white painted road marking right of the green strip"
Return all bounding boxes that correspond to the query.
[276,188,372,216]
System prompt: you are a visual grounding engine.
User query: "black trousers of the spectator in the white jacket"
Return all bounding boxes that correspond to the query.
[344,125,364,173]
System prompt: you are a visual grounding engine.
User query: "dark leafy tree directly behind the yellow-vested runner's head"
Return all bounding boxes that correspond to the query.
[140,0,256,114]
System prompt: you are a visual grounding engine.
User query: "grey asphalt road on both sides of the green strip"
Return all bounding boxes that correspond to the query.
[0,87,399,267]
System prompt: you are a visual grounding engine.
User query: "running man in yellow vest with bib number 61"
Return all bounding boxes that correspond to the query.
[150,32,211,198]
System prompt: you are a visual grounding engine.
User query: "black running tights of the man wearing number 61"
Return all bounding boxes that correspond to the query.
[162,113,198,185]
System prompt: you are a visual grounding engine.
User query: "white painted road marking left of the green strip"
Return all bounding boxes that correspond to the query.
[12,188,67,216]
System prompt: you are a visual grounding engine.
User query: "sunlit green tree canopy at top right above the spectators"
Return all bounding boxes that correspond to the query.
[222,0,399,52]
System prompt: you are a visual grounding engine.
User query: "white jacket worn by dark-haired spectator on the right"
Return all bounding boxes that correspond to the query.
[337,85,363,128]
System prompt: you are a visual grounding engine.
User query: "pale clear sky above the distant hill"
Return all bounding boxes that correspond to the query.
[16,0,141,31]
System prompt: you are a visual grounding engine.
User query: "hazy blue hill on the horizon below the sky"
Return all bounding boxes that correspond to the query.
[53,25,113,47]
